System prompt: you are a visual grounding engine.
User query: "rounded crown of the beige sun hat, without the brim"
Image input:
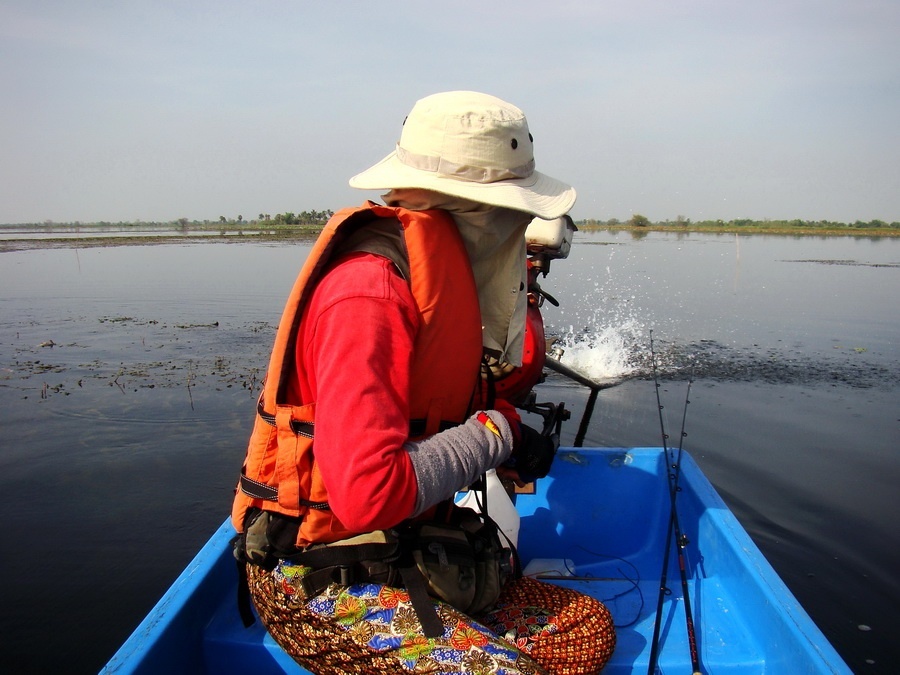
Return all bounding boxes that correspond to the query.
[397,91,534,183]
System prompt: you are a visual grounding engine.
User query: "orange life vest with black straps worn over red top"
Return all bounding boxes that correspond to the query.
[231,202,482,546]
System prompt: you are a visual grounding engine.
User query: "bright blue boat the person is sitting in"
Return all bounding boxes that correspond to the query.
[102,448,851,675]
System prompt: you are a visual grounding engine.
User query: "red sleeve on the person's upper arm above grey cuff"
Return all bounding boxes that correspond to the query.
[297,254,418,532]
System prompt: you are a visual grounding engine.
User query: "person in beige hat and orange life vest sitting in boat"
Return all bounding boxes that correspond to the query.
[232,92,615,675]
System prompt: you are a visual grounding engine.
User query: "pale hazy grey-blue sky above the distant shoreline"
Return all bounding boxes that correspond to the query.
[0,0,900,223]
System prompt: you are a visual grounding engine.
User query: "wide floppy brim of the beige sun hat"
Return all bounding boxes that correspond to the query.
[350,152,575,220]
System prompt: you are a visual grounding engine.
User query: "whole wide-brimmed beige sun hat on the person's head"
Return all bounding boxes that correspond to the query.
[350,91,575,220]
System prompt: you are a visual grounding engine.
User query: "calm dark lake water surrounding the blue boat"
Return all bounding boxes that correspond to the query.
[0,233,900,673]
